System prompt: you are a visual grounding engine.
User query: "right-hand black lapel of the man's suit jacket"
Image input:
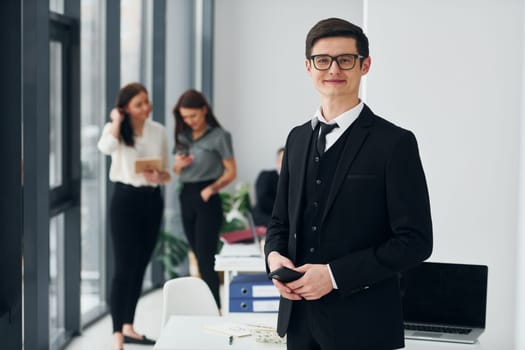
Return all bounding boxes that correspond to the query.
[321,105,373,225]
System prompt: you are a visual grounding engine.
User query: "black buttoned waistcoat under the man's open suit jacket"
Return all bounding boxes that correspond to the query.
[296,124,352,266]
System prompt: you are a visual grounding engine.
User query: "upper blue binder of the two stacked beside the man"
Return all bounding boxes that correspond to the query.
[230,273,279,298]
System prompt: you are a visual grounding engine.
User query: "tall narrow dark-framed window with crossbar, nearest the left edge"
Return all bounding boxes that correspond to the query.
[49,6,81,349]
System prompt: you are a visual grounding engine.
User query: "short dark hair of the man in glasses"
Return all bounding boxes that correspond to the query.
[306,18,369,59]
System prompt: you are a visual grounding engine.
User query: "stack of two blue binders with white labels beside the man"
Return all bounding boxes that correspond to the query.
[229,273,279,312]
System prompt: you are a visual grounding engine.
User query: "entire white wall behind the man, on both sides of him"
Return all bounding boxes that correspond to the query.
[214,0,525,350]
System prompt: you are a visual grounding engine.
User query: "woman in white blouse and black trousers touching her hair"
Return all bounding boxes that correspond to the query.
[98,83,170,350]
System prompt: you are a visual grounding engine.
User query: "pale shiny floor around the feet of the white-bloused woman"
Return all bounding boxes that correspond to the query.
[66,289,162,350]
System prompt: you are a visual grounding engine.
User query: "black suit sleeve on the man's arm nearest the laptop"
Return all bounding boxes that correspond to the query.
[330,131,432,294]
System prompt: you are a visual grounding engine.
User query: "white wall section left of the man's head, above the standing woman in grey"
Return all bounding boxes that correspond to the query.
[213,0,362,184]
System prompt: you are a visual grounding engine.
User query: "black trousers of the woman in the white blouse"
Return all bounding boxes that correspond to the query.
[109,182,164,332]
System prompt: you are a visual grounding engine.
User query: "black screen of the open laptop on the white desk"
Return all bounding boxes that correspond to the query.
[401,262,488,328]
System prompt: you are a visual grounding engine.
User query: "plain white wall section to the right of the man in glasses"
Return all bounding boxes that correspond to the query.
[367,0,523,349]
